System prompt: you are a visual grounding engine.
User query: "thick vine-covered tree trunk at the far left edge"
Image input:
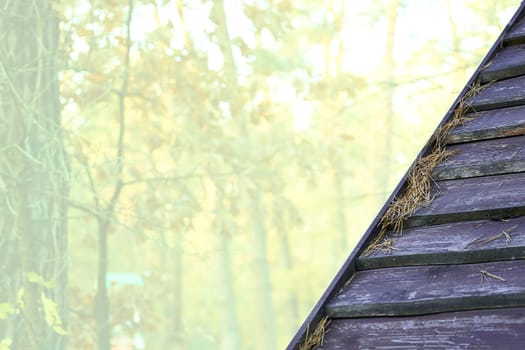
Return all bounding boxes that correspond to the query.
[0,0,68,350]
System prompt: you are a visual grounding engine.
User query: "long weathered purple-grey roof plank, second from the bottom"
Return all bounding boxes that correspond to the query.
[326,260,525,318]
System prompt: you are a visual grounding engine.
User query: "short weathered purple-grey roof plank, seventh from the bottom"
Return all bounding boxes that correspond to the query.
[466,75,525,112]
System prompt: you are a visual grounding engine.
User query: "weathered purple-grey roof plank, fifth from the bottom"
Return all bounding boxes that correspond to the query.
[432,136,525,181]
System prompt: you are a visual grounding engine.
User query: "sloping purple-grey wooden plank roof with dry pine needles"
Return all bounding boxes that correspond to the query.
[288,3,525,350]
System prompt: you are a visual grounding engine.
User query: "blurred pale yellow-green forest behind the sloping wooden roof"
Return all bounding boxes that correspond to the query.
[0,0,519,350]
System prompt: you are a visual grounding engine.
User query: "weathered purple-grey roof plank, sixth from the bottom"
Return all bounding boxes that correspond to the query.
[446,106,525,144]
